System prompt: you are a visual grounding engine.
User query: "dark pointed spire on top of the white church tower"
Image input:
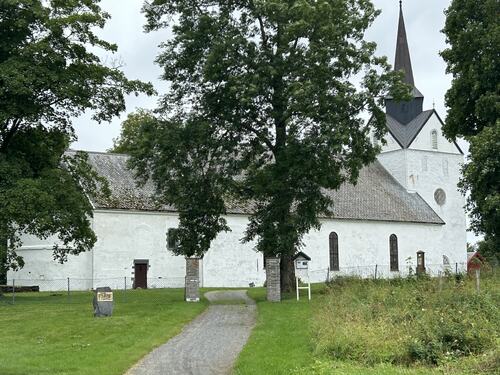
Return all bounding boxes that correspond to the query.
[385,0,424,125]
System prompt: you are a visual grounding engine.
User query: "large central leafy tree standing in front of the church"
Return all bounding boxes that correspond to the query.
[140,0,408,290]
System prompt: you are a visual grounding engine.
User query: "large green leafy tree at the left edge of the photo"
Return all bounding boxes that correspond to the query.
[0,0,153,281]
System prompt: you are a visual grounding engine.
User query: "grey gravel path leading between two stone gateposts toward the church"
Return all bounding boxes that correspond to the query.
[126,290,256,375]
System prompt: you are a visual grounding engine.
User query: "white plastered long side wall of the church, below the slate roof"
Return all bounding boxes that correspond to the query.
[9,211,464,290]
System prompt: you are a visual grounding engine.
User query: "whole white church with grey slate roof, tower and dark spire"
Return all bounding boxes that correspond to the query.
[8,7,467,290]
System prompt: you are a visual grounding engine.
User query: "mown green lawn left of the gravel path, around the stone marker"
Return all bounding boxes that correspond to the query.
[0,289,207,375]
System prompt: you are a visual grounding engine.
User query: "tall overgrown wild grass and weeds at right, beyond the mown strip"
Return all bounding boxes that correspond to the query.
[313,274,500,365]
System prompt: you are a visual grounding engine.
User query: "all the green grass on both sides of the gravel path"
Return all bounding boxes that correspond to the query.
[0,275,500,375]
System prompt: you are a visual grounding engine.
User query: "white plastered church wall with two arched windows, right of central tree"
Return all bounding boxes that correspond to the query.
[303,220,464,281]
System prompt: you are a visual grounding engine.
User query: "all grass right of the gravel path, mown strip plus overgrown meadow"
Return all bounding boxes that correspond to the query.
[234,275,500,375]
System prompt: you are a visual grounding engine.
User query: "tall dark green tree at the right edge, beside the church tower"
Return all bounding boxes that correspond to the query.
[442,0,500,253]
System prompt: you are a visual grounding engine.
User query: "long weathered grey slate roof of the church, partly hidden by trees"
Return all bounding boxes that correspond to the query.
[83,152,444,224]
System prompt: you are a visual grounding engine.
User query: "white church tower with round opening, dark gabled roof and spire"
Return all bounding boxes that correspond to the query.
[378,1,466,263]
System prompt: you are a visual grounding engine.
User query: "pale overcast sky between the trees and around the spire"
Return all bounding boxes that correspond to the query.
[72,0,458,151]
